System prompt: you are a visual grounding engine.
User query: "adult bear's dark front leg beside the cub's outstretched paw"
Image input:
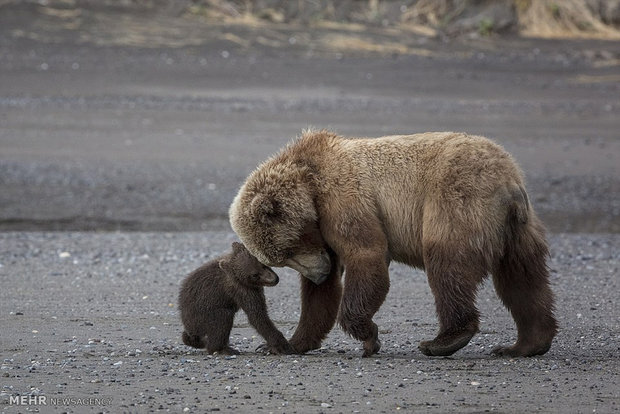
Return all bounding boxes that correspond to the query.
[289,252,342,353]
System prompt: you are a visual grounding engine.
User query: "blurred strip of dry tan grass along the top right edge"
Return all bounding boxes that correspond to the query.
[187,0,620,39]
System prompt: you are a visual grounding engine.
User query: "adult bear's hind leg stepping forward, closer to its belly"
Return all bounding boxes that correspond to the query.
[419,243,486,356]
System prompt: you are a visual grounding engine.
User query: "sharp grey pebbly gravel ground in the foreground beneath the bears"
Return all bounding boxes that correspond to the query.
[0,232,620,413]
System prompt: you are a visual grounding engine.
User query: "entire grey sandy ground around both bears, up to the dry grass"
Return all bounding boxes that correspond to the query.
[0,1,620,413]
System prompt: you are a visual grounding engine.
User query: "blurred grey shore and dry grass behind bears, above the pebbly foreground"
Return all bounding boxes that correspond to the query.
[0,0,620,232]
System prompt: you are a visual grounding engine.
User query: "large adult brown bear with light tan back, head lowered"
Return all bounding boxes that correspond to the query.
[230,131,557,356]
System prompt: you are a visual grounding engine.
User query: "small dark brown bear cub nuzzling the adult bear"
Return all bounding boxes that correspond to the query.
[179,242,295,354]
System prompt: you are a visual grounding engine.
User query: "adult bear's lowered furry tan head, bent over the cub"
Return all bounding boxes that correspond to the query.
[229,157,331,284]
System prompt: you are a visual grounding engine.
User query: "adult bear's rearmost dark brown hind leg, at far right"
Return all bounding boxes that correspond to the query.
[493,185,557,356]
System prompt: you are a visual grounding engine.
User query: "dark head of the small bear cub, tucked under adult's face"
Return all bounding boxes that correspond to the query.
[219,242,280,288]
